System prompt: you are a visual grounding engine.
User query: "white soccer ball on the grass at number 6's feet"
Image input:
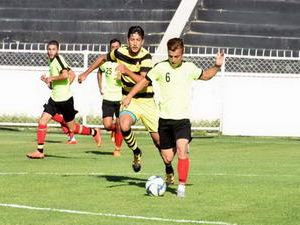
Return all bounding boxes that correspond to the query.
[146,176,167,196]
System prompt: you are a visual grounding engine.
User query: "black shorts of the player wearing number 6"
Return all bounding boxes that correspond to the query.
[158,118,192,149]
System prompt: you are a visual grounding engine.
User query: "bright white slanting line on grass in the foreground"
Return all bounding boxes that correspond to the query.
[0,203,236,225]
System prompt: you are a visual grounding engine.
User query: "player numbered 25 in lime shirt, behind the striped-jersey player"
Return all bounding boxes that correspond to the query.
[97,39,123,157]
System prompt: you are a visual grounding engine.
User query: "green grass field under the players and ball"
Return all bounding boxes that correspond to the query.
[0,129,300,225]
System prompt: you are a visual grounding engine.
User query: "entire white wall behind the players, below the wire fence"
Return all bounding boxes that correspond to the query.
[0,59,300,136]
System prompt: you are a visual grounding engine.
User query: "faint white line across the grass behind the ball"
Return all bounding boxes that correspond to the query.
[0,172,299,177]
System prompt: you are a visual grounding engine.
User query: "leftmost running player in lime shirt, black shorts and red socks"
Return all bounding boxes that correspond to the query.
[27,40,101,159]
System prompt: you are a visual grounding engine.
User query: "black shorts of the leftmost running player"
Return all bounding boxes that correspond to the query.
[44,97,78,122]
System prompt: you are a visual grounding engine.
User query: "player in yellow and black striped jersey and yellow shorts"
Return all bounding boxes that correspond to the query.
[78,26,174,178]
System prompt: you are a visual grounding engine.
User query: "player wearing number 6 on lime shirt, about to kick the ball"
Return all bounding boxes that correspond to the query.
[122,38,224,197]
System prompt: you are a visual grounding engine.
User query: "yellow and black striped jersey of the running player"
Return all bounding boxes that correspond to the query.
[107,46,154,98]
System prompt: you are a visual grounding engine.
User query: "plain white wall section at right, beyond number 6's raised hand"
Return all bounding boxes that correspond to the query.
[222,74,300,136]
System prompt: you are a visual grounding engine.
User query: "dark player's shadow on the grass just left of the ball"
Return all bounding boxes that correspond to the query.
[98,175,147,188]
